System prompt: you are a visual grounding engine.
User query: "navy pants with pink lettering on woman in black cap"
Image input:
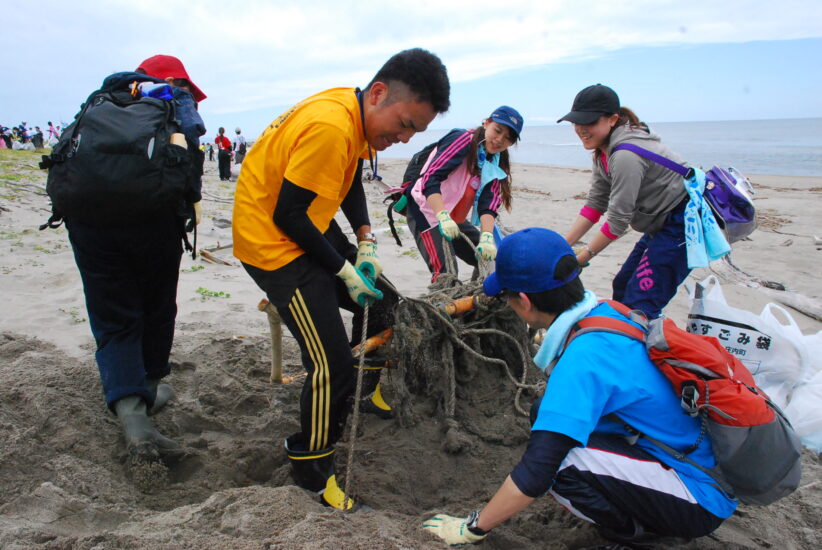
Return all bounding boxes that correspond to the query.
[612,202,691,319]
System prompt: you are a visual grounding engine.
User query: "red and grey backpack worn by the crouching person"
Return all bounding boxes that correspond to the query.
[565,300,802,505]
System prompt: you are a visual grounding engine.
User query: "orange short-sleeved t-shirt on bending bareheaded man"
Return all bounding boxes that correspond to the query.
[232,88,367,271]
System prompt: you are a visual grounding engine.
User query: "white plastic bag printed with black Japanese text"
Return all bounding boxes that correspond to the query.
[687,275,813,410]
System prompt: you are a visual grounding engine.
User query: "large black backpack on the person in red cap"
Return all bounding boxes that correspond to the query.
[40,90,192,229]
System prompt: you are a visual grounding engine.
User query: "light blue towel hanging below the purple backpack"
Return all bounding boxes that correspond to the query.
[683,168,731,269]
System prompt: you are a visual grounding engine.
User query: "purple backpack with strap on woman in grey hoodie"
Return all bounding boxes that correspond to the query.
[612,143,756,243]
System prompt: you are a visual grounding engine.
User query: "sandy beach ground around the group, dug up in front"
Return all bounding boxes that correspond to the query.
[0,150,822,550]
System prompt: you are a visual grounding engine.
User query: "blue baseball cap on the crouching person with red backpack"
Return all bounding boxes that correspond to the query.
[482,227,580,296]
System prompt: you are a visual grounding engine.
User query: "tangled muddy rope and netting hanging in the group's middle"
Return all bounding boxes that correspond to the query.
[387,235,545,452]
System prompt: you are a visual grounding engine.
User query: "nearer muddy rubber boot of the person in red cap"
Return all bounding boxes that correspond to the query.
[114,395,183,462]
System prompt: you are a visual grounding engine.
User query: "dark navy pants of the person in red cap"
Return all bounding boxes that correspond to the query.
[66,216,183,408]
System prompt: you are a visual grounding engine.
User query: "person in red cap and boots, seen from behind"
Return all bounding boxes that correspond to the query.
[65,55,206,474]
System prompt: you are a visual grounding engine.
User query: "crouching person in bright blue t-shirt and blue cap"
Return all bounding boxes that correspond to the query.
[423,227,737,548]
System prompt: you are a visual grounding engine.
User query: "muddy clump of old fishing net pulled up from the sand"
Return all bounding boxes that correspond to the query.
[380,239,545,453]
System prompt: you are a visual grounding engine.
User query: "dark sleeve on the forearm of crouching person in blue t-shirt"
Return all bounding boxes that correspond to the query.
[511,430,579,498]
